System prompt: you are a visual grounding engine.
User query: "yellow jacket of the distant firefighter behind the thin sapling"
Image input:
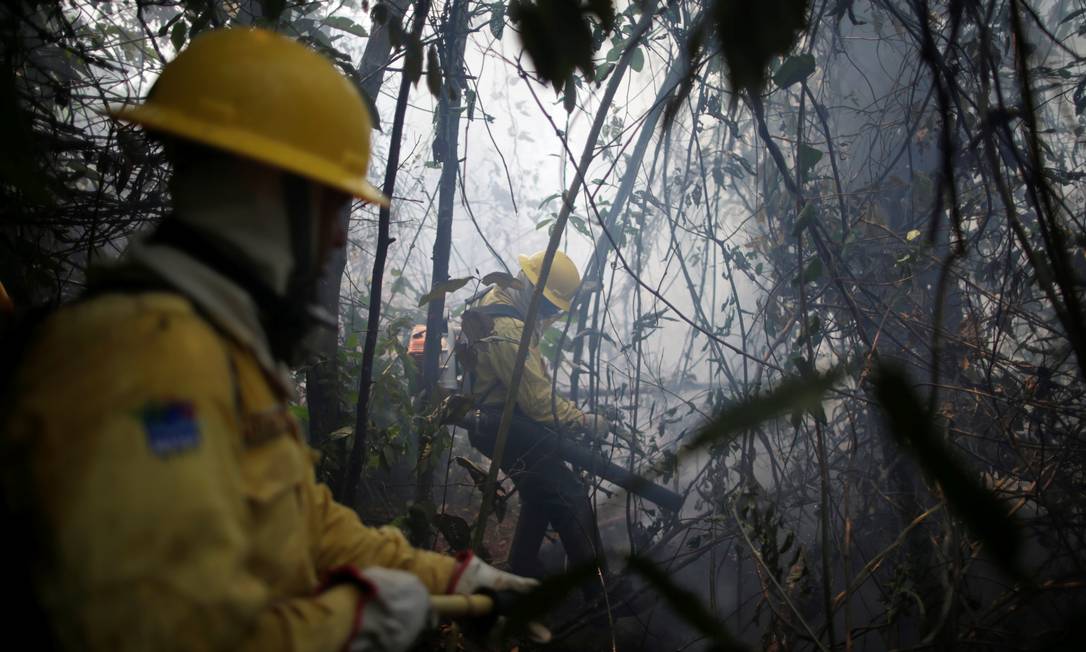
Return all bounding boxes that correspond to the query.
[472,287,584,425]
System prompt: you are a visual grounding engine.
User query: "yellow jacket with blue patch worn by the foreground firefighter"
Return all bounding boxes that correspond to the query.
[4,292,456,651]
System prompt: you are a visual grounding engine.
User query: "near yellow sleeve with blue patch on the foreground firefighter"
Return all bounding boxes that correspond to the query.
[4,297,356,652]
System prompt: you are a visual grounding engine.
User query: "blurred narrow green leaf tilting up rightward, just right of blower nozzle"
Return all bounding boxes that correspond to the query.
[690,369,841,449]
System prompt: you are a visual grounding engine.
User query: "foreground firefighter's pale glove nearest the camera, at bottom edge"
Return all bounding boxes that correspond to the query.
[326,566,437,652]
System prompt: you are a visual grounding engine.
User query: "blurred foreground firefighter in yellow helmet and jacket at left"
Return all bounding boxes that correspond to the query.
[3,29,534,651]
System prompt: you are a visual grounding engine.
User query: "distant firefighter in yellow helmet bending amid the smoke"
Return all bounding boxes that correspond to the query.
[458,251,609,597]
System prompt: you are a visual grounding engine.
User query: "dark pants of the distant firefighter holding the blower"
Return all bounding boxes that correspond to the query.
[468,409,606,593]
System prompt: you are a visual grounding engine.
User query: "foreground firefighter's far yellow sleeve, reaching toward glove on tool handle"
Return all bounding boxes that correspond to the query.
[316,485,457,593]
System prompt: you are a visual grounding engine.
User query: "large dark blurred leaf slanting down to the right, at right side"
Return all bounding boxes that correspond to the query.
[873,364,1022,578]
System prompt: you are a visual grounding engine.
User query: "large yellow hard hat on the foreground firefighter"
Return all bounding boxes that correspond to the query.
[110,28,389,205]
